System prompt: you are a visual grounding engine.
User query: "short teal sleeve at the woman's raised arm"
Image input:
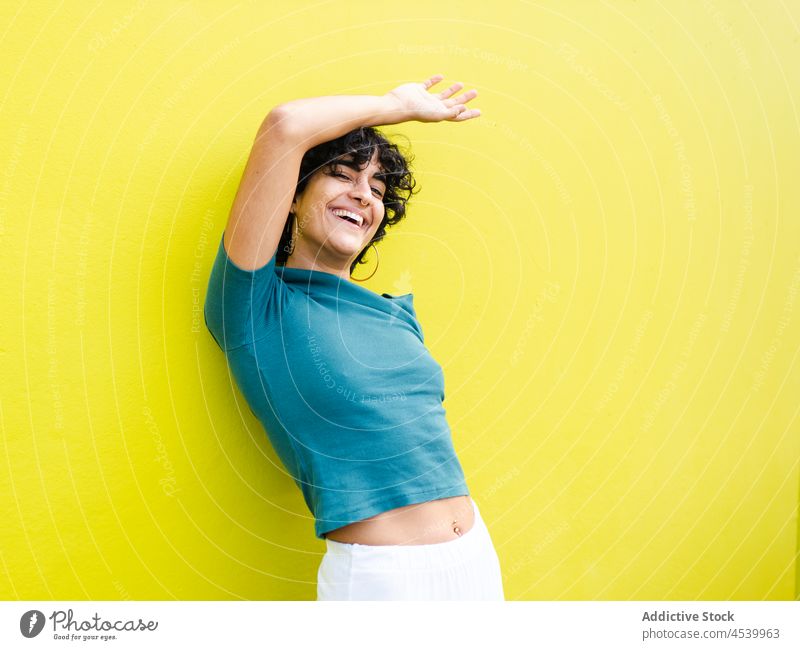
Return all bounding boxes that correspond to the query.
[204,233,280,352]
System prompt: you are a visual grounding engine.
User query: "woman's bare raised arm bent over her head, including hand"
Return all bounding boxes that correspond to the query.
[224,75,480,270]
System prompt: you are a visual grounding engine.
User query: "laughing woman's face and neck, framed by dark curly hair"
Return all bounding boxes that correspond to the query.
[286,152,386,278]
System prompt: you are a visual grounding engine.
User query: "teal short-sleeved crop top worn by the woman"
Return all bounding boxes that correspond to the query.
[204,232,469,539]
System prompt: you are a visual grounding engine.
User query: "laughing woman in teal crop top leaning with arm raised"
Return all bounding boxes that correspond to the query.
[205,75,503,600]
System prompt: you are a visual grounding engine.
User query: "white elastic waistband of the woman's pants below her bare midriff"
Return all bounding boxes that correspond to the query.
[325,496,491,560]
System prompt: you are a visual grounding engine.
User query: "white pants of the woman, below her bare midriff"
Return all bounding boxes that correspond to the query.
[317,501,505,600]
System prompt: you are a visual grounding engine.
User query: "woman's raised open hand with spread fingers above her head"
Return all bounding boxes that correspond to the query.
[386,74,481,122]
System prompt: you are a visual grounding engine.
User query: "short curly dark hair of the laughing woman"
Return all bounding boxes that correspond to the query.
[275,126,417,275]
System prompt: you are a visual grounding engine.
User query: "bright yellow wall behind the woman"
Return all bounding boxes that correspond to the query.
[0,0,800,600]
